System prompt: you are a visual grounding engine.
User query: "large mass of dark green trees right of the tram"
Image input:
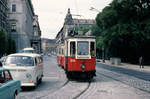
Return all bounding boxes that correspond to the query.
[92,0,150,63]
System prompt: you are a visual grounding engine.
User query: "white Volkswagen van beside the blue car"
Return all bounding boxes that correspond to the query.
[3,53,43,87]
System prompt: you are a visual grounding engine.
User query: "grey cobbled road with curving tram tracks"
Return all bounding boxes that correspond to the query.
[17,56,150,99]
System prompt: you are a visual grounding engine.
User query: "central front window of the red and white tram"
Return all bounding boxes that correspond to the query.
[78,42,89,55]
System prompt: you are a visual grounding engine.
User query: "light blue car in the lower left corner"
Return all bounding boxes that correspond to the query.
[0,68,21,99]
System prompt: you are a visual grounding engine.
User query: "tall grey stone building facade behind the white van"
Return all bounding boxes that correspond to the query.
[8,0,41,52]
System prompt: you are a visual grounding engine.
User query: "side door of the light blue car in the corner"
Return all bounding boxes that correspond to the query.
[0,71,11,99]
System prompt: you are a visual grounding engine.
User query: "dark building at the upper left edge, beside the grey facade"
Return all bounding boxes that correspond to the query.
[0,0,8,31]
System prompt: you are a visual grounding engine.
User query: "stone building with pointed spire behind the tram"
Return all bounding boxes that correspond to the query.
[56,9,96,44]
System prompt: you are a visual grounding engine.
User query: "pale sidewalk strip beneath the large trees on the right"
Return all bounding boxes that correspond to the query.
[98,60,150,72]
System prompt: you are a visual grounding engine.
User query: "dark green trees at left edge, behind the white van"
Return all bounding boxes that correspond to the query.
[0,29,16,57]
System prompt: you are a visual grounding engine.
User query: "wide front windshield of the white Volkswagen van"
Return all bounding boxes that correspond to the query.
[5,56,34,66]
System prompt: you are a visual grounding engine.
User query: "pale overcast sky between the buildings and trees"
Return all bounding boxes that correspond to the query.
[32,0,112,39]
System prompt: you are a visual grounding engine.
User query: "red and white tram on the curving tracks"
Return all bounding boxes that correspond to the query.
[57,36,96,79]
